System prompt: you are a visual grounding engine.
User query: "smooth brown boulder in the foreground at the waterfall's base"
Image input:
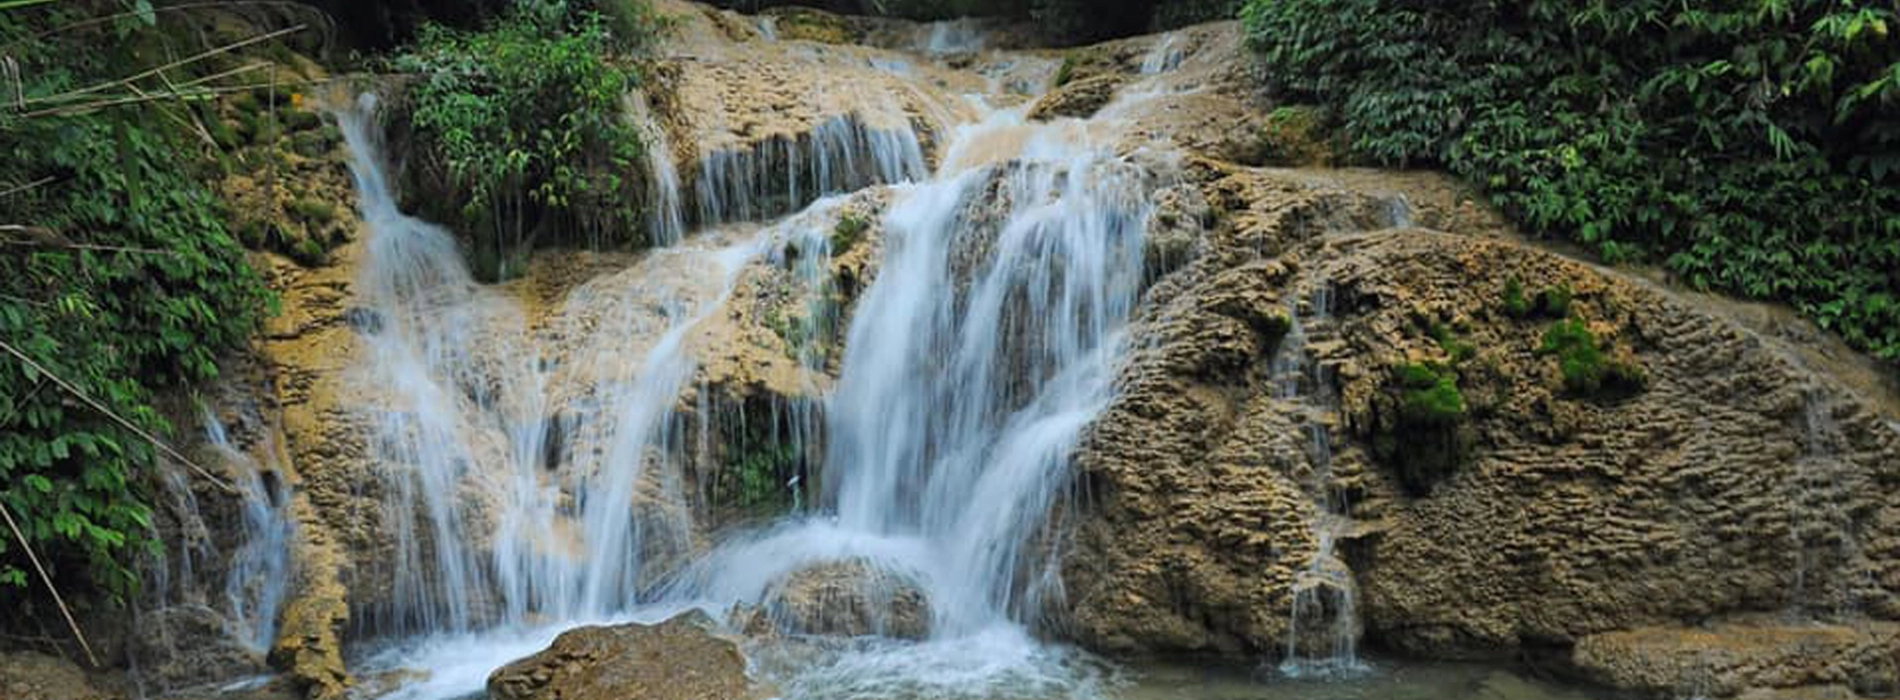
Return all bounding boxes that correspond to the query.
[488,611,762,700]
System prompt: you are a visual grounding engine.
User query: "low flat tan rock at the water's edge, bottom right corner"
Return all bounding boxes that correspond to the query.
[1571,620,1900,698]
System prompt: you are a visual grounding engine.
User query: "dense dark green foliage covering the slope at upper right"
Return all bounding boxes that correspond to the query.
[1245,0,1900,360]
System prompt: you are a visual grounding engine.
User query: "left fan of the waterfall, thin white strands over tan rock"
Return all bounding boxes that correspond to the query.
[340,94,779,633]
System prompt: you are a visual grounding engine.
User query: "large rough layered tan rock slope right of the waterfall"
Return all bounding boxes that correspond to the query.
[1064,16,1900,694]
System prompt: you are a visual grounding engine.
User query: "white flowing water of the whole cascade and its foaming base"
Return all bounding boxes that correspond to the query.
[292,15,1618,700]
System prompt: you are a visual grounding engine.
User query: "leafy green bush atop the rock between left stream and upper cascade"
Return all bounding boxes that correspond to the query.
[393,2,646,278]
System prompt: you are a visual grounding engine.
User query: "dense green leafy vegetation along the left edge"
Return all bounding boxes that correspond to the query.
[0,0,270,608]
